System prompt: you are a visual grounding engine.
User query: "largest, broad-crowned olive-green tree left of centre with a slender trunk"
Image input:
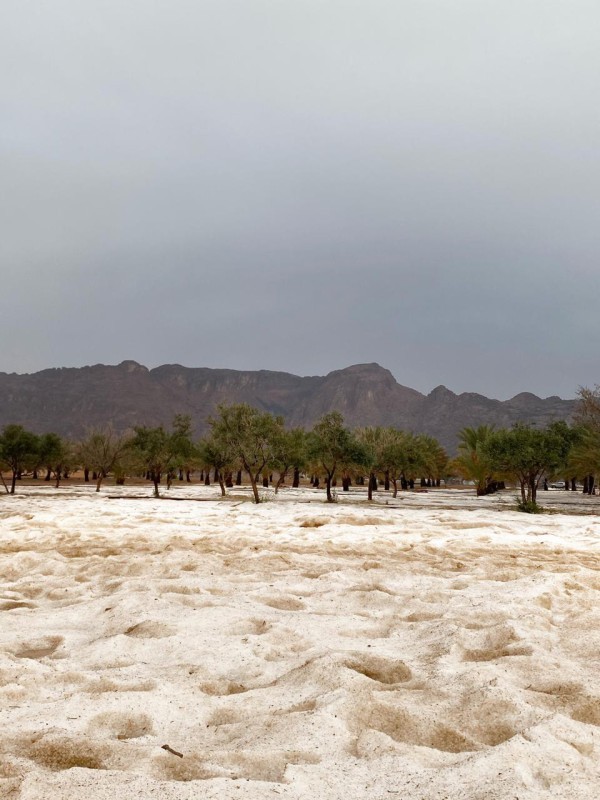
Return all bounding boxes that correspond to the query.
[209,403,283,503]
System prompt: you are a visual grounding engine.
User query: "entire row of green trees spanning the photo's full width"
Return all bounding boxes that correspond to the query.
[0,388,600,504]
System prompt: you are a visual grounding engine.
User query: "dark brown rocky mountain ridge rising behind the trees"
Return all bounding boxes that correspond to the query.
[0,361,575,453]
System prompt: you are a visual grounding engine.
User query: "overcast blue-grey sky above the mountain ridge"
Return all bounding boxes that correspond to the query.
[0,0,600,399]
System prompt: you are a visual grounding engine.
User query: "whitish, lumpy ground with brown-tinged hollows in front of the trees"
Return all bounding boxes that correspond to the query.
[0,486,600,800]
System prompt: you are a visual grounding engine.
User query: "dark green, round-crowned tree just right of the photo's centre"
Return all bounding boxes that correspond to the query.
[307,411,368,503]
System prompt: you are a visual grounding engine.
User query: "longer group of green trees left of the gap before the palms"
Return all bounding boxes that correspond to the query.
[0,404,448,503]
